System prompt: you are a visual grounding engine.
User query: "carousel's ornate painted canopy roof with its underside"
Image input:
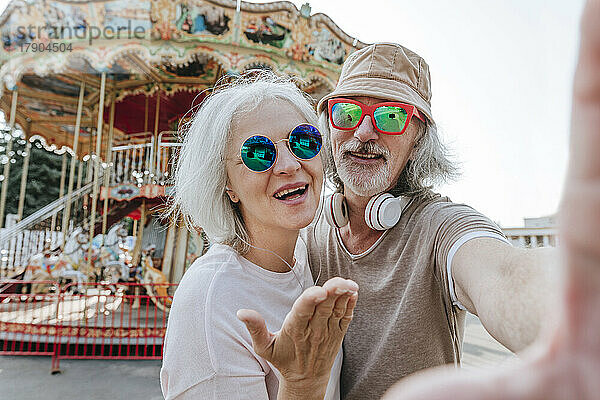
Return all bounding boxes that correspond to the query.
[0,0,365,156]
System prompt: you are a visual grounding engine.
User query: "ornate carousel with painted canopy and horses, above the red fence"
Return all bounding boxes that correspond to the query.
[0,0,364,309]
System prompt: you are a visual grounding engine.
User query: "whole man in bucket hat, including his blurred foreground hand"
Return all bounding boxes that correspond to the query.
[240,0,600,399]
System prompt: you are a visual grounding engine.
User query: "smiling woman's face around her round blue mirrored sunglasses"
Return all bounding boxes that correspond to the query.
[226,101,323,235]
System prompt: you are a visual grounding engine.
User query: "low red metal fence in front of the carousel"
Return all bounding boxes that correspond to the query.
[0,281,176,371]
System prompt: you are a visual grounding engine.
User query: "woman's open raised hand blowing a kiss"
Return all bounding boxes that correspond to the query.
[237,278,358,399]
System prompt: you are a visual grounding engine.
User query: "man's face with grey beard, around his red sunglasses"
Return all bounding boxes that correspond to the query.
[329,97,419,197]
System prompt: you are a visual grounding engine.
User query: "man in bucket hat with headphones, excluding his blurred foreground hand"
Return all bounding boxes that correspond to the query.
[298,39,556,400]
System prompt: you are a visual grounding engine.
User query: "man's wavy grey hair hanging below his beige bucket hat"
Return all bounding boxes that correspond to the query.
[319,111,459,196]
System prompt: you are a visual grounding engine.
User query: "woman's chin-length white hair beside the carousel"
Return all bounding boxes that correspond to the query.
[169,70,317,254]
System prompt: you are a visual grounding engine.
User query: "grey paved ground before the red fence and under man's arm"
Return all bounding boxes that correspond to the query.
[0,315,515,400]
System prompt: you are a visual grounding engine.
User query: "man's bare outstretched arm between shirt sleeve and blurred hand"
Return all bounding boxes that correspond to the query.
[452,238,560,352]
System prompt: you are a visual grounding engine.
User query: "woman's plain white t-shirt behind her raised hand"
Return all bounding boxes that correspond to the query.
[160,240,342,400]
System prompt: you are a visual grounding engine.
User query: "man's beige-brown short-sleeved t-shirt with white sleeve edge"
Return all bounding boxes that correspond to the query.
[303,193,505,400]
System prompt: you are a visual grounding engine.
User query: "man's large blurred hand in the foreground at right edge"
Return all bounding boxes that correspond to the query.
[384,0,600,400]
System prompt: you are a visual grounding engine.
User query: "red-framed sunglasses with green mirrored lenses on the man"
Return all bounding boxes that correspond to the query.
[327,98,425,135]
